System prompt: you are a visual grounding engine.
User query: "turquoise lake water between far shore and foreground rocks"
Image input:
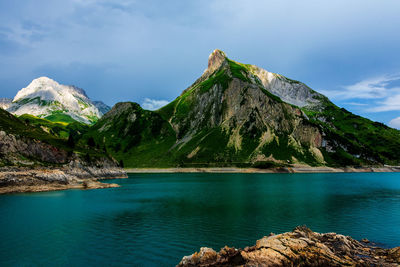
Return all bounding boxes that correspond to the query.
[0,173,400,266]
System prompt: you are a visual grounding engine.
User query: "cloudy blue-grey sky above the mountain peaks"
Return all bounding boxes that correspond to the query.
[0,0,400,129]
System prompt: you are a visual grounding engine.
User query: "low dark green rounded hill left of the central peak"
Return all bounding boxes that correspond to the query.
[80,103,175,167]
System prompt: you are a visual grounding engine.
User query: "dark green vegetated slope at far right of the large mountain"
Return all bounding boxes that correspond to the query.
[303,101,400,166]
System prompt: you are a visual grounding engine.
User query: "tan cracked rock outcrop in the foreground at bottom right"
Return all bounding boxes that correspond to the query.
[177,226,400,267]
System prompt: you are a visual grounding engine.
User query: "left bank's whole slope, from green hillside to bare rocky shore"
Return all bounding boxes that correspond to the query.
[0,109,127,193]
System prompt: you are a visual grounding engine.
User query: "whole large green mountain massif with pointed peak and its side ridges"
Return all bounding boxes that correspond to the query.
[83,50,400,167]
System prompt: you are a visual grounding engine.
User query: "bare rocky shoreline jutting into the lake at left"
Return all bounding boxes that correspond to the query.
[0,161,128,194]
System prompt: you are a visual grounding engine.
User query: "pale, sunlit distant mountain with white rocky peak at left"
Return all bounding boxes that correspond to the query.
[7,77,107,124]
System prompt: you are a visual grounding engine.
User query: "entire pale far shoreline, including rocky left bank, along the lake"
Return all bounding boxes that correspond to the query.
[0,166,400,195]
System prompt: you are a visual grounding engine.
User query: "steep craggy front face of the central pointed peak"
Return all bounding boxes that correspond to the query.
[159,50,324,164]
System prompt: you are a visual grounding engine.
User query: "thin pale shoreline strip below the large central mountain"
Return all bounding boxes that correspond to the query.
[124,166,400,173]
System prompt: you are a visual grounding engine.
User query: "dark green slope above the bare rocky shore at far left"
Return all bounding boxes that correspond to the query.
[0,108,109,167]
